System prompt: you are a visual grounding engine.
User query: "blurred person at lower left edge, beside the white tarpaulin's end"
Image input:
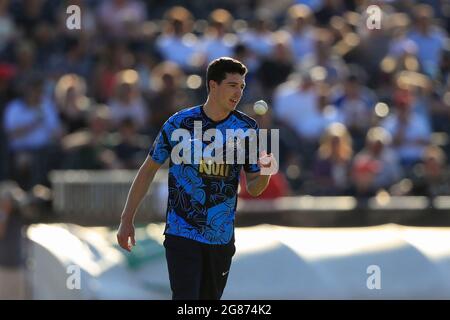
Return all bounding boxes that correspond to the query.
[0,181,27,300]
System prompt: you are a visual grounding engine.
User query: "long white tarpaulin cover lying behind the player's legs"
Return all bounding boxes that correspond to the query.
[28,224,450,299]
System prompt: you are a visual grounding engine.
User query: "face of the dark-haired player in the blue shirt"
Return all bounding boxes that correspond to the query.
[210,73,245,111]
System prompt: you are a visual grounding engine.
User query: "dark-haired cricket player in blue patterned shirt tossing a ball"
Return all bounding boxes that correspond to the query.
[117,58,277,300]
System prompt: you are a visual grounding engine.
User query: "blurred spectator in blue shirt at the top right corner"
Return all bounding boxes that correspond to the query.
[408,4,447,79]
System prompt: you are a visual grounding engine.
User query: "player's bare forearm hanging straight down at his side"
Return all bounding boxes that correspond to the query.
[121,167,156,221]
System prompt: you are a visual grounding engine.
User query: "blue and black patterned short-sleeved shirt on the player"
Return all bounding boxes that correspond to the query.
[149,106,260,244]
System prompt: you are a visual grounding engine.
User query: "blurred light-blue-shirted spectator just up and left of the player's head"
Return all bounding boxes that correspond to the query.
[156,6,201,71]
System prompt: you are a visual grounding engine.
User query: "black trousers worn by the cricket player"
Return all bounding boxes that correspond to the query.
[164,235,236,300]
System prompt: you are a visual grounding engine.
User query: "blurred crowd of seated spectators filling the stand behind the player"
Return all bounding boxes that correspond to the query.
[0,0,450,197]
